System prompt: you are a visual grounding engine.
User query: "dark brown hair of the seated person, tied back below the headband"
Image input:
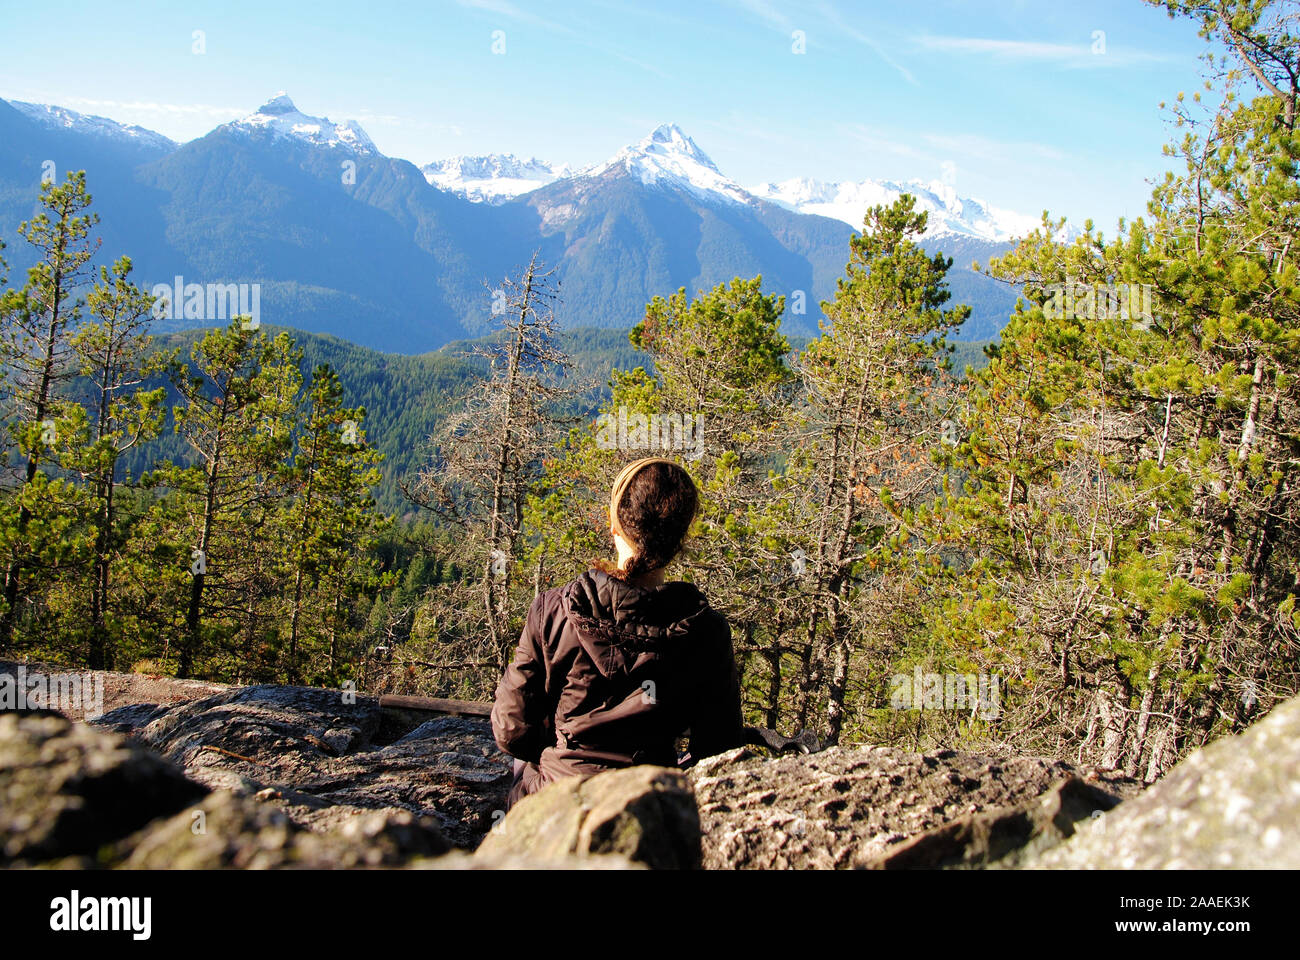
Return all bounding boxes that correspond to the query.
[597,460,699,580]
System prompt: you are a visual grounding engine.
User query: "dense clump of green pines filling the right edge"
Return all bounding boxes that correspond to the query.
[936,0,1300,779]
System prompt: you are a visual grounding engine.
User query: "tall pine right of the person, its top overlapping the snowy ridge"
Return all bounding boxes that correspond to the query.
[798,194,970,743]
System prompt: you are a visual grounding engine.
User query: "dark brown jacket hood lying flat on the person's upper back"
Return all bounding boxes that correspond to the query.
[562,570,712,676]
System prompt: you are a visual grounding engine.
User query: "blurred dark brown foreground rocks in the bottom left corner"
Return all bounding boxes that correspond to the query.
[0,712,451,869]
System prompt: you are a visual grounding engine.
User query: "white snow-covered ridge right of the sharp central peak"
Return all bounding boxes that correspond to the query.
[753,177,1040,243]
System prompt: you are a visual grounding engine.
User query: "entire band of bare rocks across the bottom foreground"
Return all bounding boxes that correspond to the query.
[10,665,1300,869]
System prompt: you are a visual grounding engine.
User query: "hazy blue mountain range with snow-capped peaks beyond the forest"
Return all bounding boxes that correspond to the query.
[0,94,1014,343]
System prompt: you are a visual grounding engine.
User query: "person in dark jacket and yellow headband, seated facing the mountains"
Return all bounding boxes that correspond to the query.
[491,457,744,805]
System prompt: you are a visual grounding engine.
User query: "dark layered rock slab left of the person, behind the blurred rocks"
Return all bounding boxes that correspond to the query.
[96,684,510,848]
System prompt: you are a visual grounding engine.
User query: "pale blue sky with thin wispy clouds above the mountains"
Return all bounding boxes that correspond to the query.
[0,0,1205,233]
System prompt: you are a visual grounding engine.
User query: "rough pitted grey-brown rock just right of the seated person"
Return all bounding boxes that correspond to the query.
[690,747,1140,869]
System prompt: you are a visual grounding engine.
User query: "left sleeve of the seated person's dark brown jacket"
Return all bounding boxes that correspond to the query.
[491,594,553,764]
